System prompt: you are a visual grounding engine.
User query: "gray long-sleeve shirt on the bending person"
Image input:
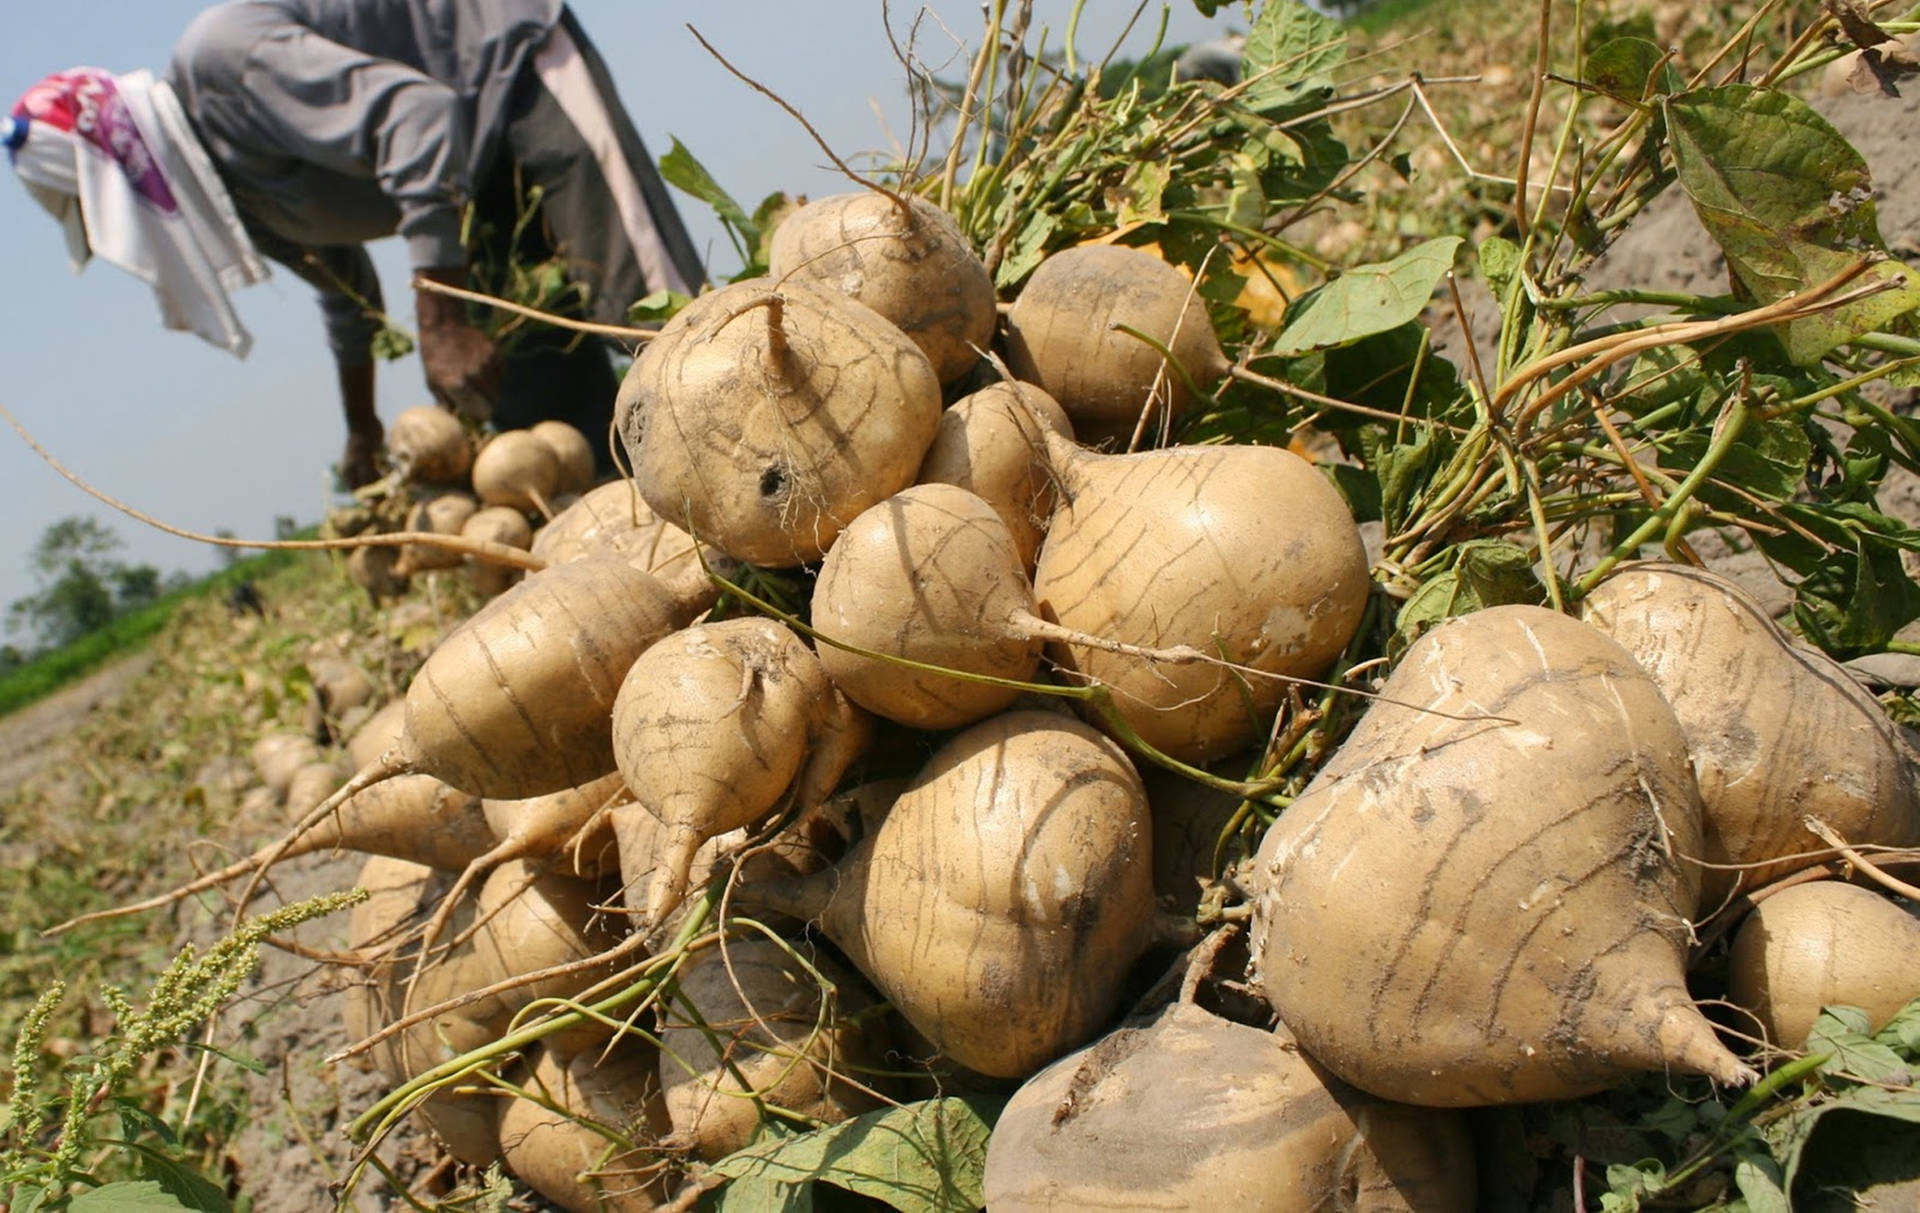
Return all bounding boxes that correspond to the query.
[167,0,563,363]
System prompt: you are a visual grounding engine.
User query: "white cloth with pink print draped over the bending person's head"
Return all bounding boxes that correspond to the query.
[10,67,267,357]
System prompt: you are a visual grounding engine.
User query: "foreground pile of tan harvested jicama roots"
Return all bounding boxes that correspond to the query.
[78,190,1920,1209]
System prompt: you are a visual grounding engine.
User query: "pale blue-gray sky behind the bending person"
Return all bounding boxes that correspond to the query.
[0,0,1236,607]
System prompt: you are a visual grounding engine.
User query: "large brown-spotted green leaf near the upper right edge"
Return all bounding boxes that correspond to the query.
[1665,84,1920,367]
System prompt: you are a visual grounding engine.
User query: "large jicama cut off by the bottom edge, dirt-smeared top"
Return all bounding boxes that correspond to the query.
[985,1004,1476,1213]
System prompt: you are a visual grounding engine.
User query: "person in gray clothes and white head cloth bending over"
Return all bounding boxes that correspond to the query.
[0,0,703,486]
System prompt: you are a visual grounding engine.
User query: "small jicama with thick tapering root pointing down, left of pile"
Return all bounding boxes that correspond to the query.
[612,618,872,925]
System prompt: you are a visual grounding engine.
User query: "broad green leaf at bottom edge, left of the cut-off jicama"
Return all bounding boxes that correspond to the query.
[714,1096,1000,1213]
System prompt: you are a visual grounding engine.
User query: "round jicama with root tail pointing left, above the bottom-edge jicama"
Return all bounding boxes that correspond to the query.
[743,712,1154,1079]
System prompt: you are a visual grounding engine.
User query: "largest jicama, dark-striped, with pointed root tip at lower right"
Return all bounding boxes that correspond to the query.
[1254,607,1751,1106]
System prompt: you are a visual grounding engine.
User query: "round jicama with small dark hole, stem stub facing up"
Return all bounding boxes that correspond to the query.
[616,278,941,568]
